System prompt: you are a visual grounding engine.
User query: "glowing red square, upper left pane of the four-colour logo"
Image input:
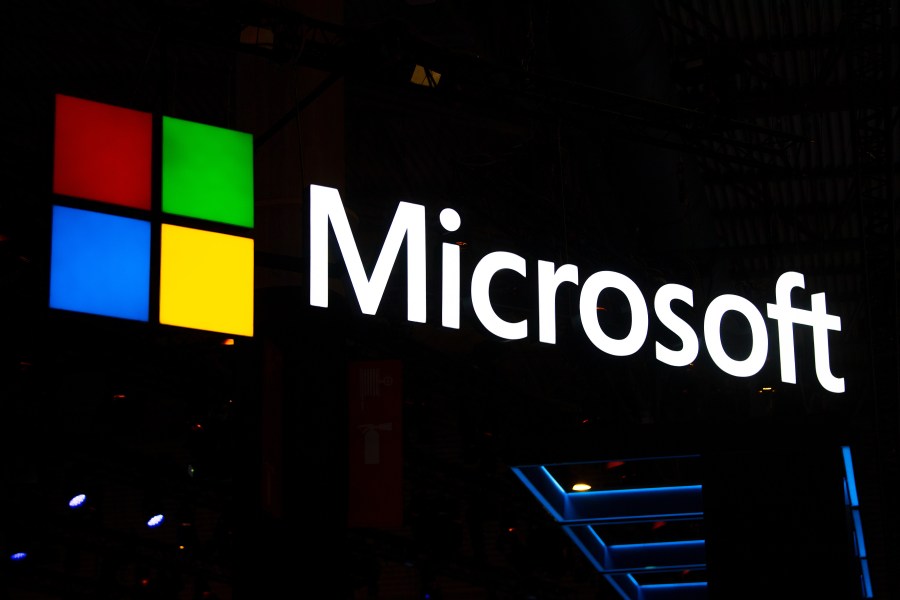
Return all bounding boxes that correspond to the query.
[53,94,153,210]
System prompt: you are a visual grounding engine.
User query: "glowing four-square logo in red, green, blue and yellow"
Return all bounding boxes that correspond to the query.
[50,95,254,336]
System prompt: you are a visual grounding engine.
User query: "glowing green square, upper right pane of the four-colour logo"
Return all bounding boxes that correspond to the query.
[162,117,253,227]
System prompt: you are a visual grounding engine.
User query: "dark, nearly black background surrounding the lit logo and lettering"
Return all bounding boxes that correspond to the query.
[0,0,900,600]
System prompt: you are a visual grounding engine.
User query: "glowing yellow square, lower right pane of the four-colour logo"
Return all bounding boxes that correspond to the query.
[159,224,254,336]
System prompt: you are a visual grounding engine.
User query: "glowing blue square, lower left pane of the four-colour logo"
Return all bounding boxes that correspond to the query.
[50,206,150,321]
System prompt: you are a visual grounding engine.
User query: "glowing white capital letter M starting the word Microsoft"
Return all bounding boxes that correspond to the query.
[309,185,425,323]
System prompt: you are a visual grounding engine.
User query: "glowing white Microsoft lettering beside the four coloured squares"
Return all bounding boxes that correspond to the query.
[309,185,844,393]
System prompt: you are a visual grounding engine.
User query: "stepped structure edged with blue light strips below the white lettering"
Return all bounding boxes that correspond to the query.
[512,457,707,600]
